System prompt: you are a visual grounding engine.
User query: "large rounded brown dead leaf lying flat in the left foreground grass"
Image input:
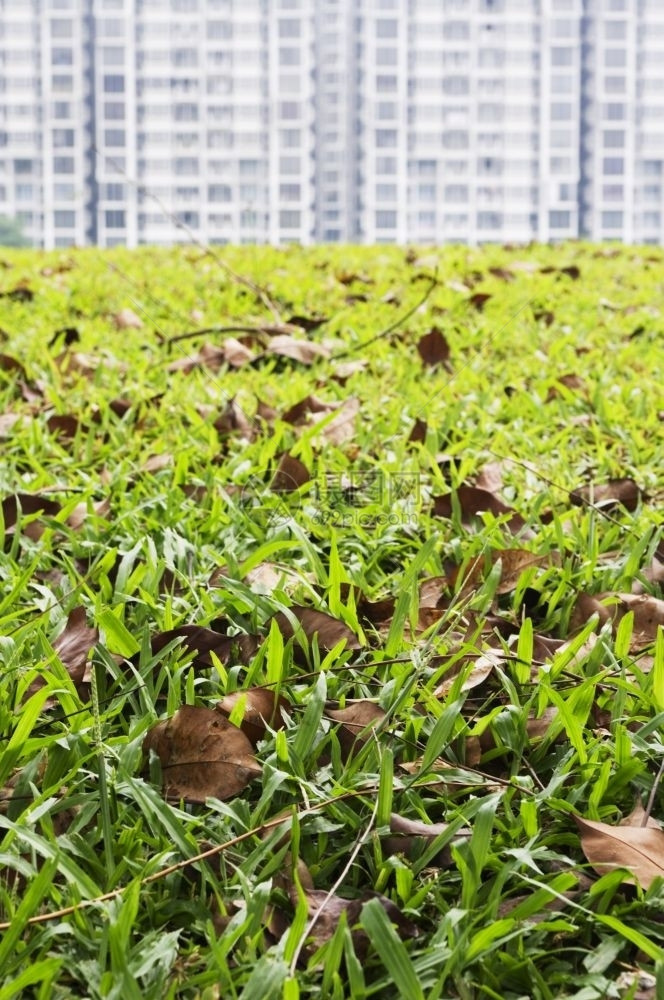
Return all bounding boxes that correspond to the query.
[143,705,261,802]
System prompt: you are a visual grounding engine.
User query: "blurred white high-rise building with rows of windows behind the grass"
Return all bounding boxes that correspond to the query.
[0,0,664,247]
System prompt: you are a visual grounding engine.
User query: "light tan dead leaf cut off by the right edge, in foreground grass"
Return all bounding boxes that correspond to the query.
[574,816,664,889]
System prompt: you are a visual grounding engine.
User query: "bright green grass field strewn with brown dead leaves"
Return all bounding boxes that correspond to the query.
[0,244,664,1000]
